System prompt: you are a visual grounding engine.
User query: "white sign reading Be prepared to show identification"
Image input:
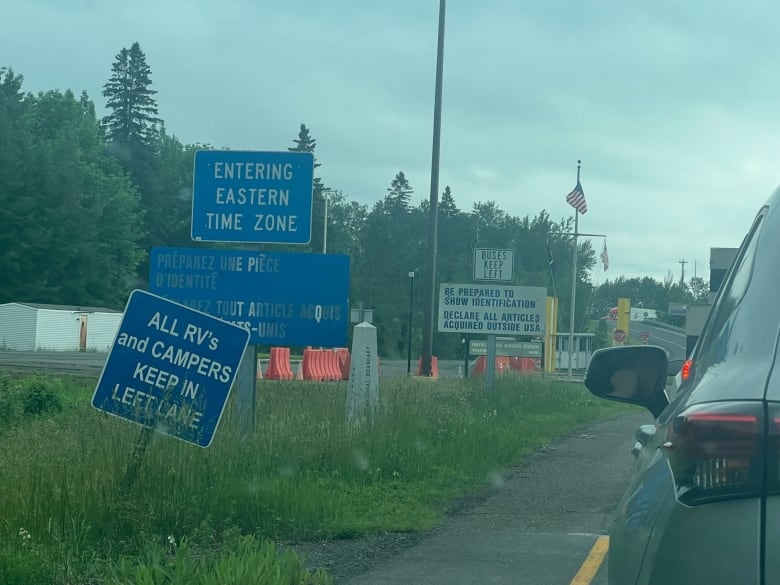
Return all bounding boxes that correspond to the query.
[439,283,547,335]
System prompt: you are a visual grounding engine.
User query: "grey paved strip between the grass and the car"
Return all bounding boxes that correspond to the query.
[337,413,651,585]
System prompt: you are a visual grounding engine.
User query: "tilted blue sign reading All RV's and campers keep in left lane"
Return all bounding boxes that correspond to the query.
[92,290,249,447]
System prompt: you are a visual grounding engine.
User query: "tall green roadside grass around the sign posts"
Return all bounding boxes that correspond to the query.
[0,376,633,585]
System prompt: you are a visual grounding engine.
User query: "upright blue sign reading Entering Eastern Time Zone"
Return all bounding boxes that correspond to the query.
[192,150,314,244]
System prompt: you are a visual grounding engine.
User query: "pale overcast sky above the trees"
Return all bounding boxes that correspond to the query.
[6,0,780,284]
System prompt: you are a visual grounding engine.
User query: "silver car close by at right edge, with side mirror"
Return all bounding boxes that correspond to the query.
[585,189,780,585]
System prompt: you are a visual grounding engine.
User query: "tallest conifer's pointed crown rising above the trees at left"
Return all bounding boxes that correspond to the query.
[103,41,160,149]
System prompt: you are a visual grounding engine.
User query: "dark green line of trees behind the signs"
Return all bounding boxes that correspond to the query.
[0,42,708,357]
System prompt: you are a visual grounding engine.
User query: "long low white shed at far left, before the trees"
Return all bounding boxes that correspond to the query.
[0,303,123,352]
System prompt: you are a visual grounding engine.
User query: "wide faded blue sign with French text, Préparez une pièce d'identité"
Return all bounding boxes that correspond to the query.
[149,248,349,347]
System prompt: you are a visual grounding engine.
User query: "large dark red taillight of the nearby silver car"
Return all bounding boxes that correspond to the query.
[664,402,764,505]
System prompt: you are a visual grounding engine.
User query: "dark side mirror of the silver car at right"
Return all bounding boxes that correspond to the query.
[585,345,670,418]
